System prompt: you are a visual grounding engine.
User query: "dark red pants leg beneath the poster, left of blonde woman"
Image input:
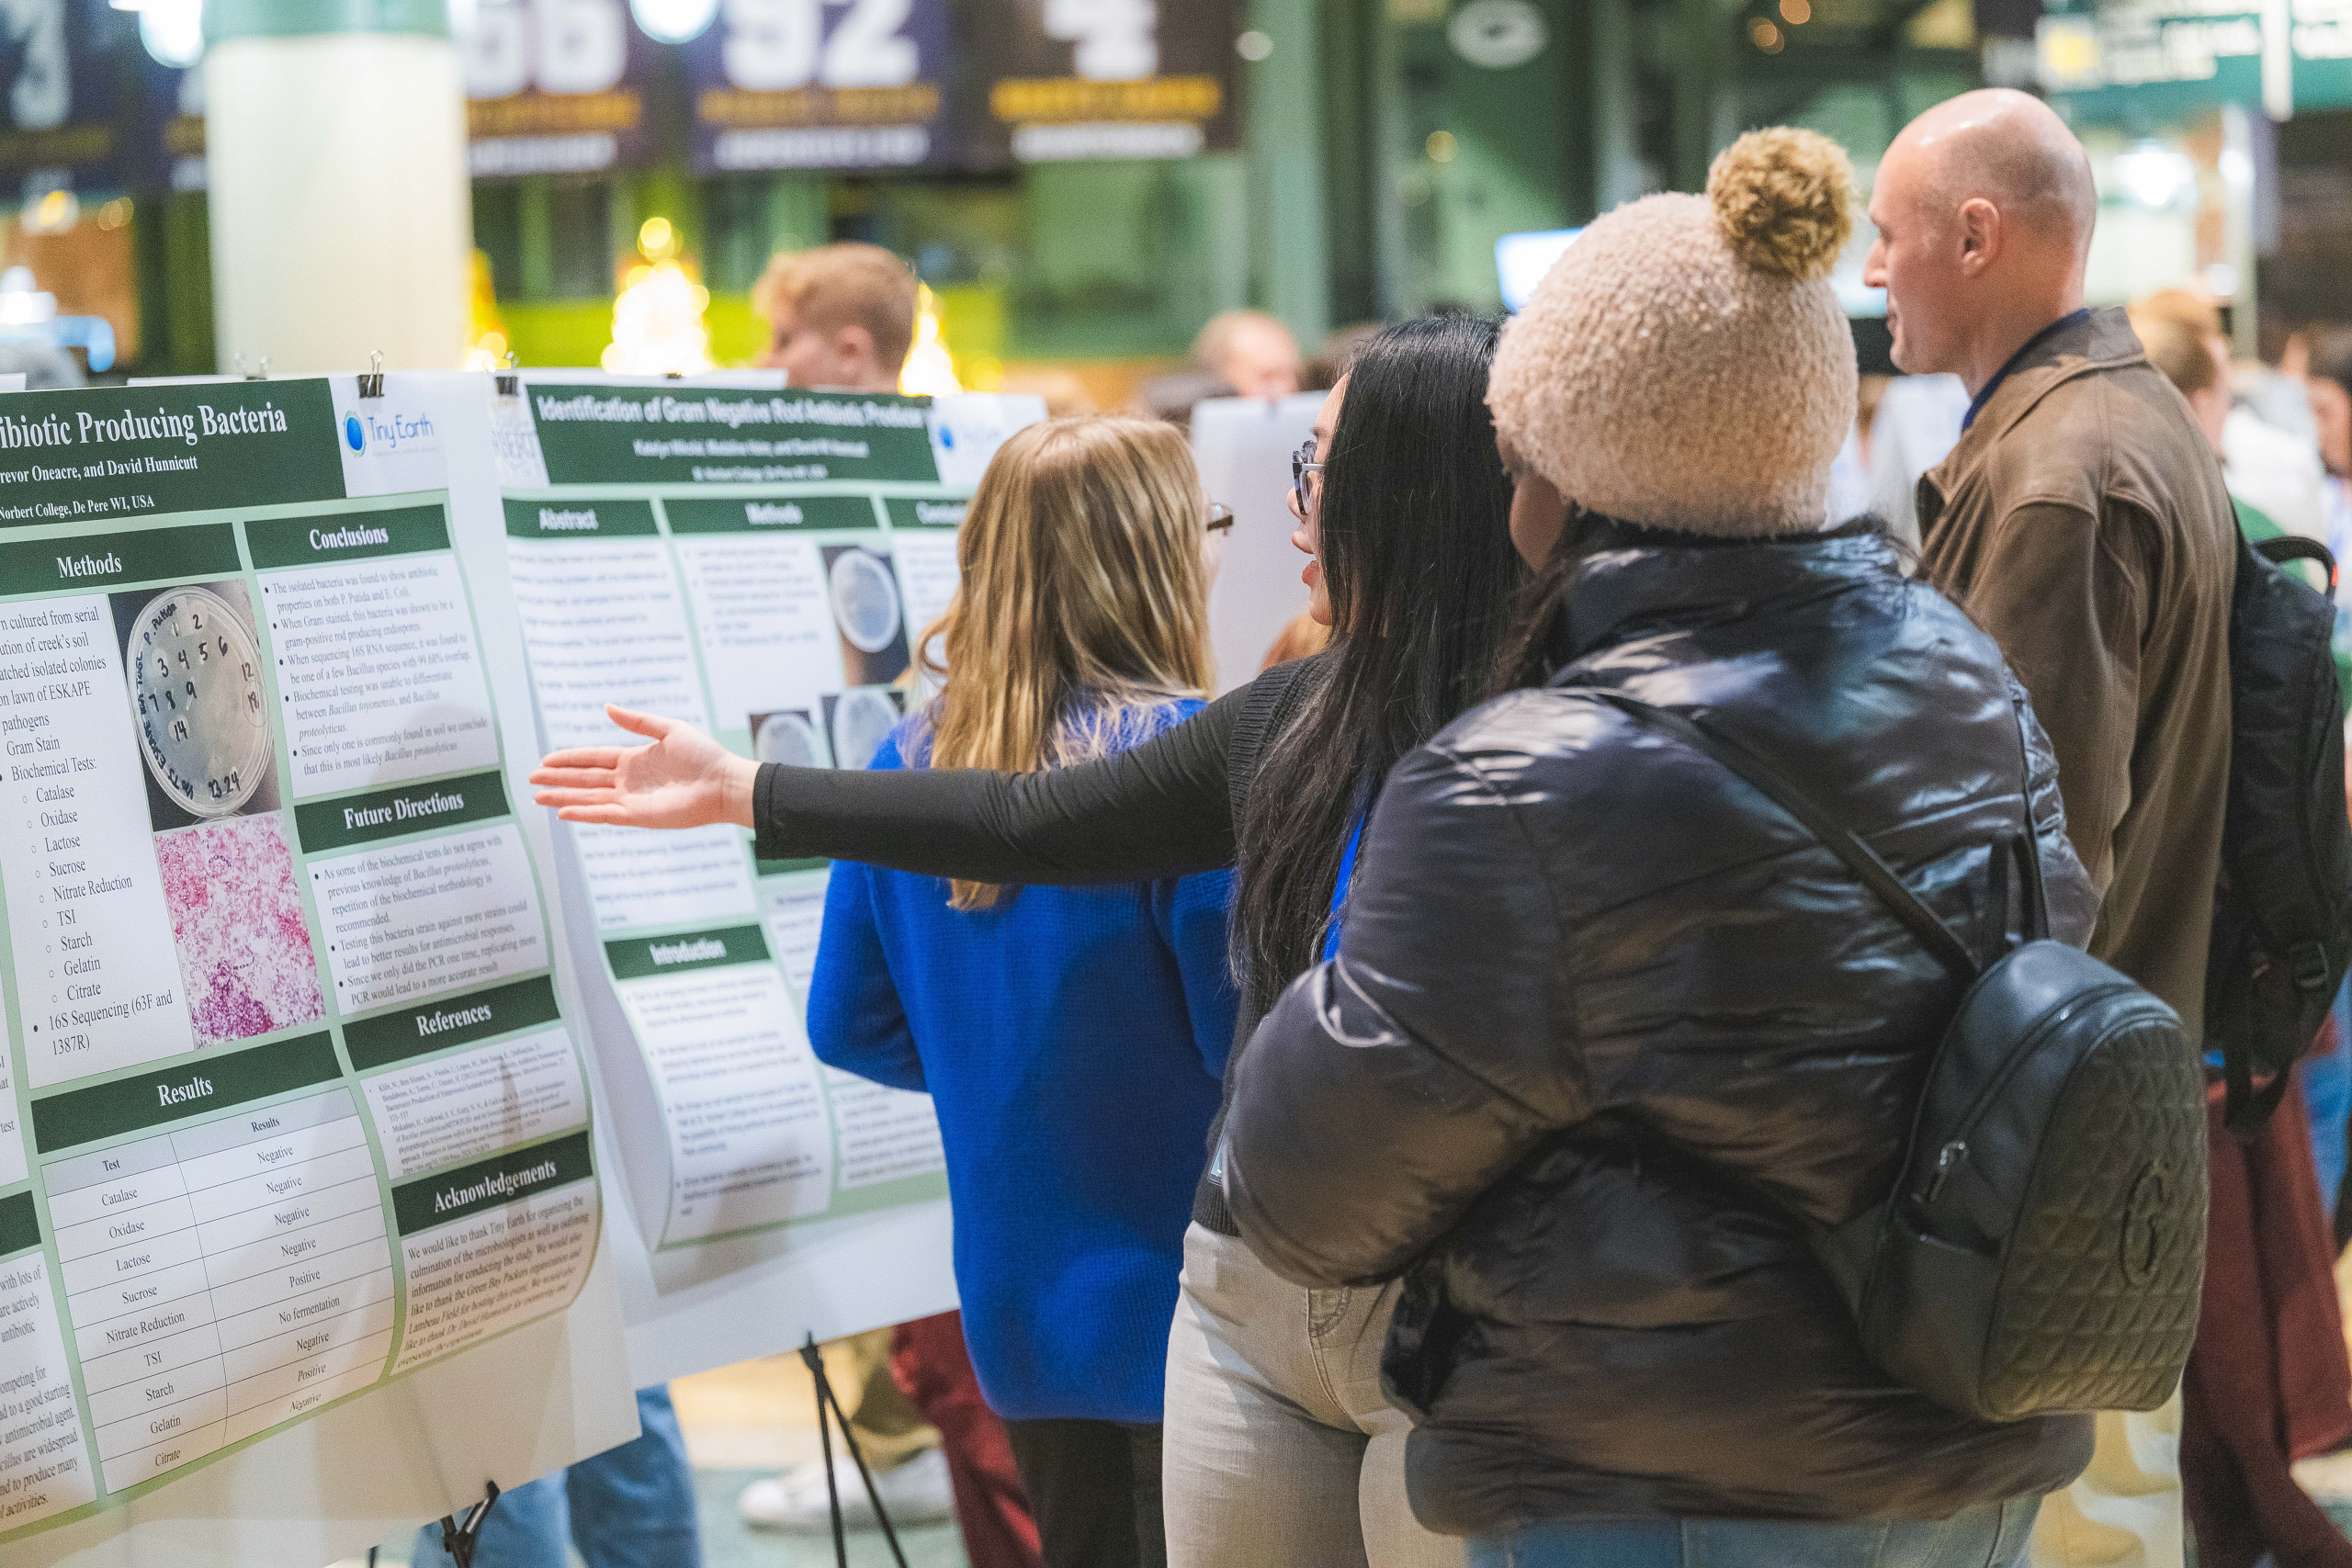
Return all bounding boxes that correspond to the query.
[889,1312,1045,1568]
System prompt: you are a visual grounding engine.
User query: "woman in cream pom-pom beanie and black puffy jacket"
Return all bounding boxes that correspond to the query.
[1223,130,2093,1568]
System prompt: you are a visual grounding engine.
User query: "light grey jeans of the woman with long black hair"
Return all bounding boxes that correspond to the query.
[1159,1224,1465,1568]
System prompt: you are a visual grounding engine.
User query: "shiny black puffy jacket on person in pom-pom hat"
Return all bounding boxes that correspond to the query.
[1223,525,2096,1535]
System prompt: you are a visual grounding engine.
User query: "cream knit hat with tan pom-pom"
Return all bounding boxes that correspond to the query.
[1487,127,1856,536]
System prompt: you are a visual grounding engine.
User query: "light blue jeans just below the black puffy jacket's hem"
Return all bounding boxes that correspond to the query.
[1470,1497,2041,1568]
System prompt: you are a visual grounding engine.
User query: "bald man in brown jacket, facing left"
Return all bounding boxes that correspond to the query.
[1863,92,2237,1568]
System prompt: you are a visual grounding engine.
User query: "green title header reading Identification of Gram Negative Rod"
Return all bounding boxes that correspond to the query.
[525,386,938,487]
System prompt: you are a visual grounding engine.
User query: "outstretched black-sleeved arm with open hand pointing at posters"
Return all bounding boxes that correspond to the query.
[532,686,1249,884]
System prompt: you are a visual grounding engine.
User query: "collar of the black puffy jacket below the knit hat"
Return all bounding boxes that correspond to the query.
[1550,517,1898,668]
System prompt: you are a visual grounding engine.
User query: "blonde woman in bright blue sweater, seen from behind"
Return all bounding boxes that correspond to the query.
[809,419,1235,1565]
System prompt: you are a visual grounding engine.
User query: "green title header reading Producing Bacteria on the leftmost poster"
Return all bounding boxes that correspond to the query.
[0,378,344,526]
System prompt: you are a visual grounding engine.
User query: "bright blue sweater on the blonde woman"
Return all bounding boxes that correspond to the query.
[809,703,1235,1422]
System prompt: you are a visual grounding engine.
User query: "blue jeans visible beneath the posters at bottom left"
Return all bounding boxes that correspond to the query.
[409,1384,703,1568]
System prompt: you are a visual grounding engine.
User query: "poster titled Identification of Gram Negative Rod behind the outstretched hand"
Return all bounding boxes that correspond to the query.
[489,371,1042,1378]
